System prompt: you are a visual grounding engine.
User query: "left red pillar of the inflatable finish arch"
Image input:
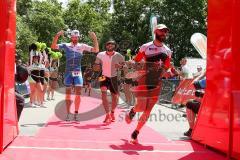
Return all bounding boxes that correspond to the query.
[0,0,18,152]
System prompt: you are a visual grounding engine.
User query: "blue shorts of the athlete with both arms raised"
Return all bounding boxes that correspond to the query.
[64,72,83,87]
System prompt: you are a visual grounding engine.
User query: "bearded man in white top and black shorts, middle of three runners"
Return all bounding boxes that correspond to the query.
[95,40,124,124]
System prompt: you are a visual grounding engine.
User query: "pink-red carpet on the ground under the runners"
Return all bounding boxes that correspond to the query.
[0,97,225,160]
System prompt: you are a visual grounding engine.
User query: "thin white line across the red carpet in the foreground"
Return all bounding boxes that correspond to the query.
[8,146,208,153]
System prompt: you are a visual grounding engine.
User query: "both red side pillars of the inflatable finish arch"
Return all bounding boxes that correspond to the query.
[0,0,240,158]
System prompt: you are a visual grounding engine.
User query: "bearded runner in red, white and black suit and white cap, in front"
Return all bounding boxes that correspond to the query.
[125,24,172,144]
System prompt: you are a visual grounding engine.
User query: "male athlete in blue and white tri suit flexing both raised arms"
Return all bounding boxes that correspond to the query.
[51,30,99,121]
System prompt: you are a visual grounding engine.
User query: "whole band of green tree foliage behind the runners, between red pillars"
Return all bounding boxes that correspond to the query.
[17,0,207,64]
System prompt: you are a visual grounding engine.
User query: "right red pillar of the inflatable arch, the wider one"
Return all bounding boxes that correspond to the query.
[193,0,240,158]
